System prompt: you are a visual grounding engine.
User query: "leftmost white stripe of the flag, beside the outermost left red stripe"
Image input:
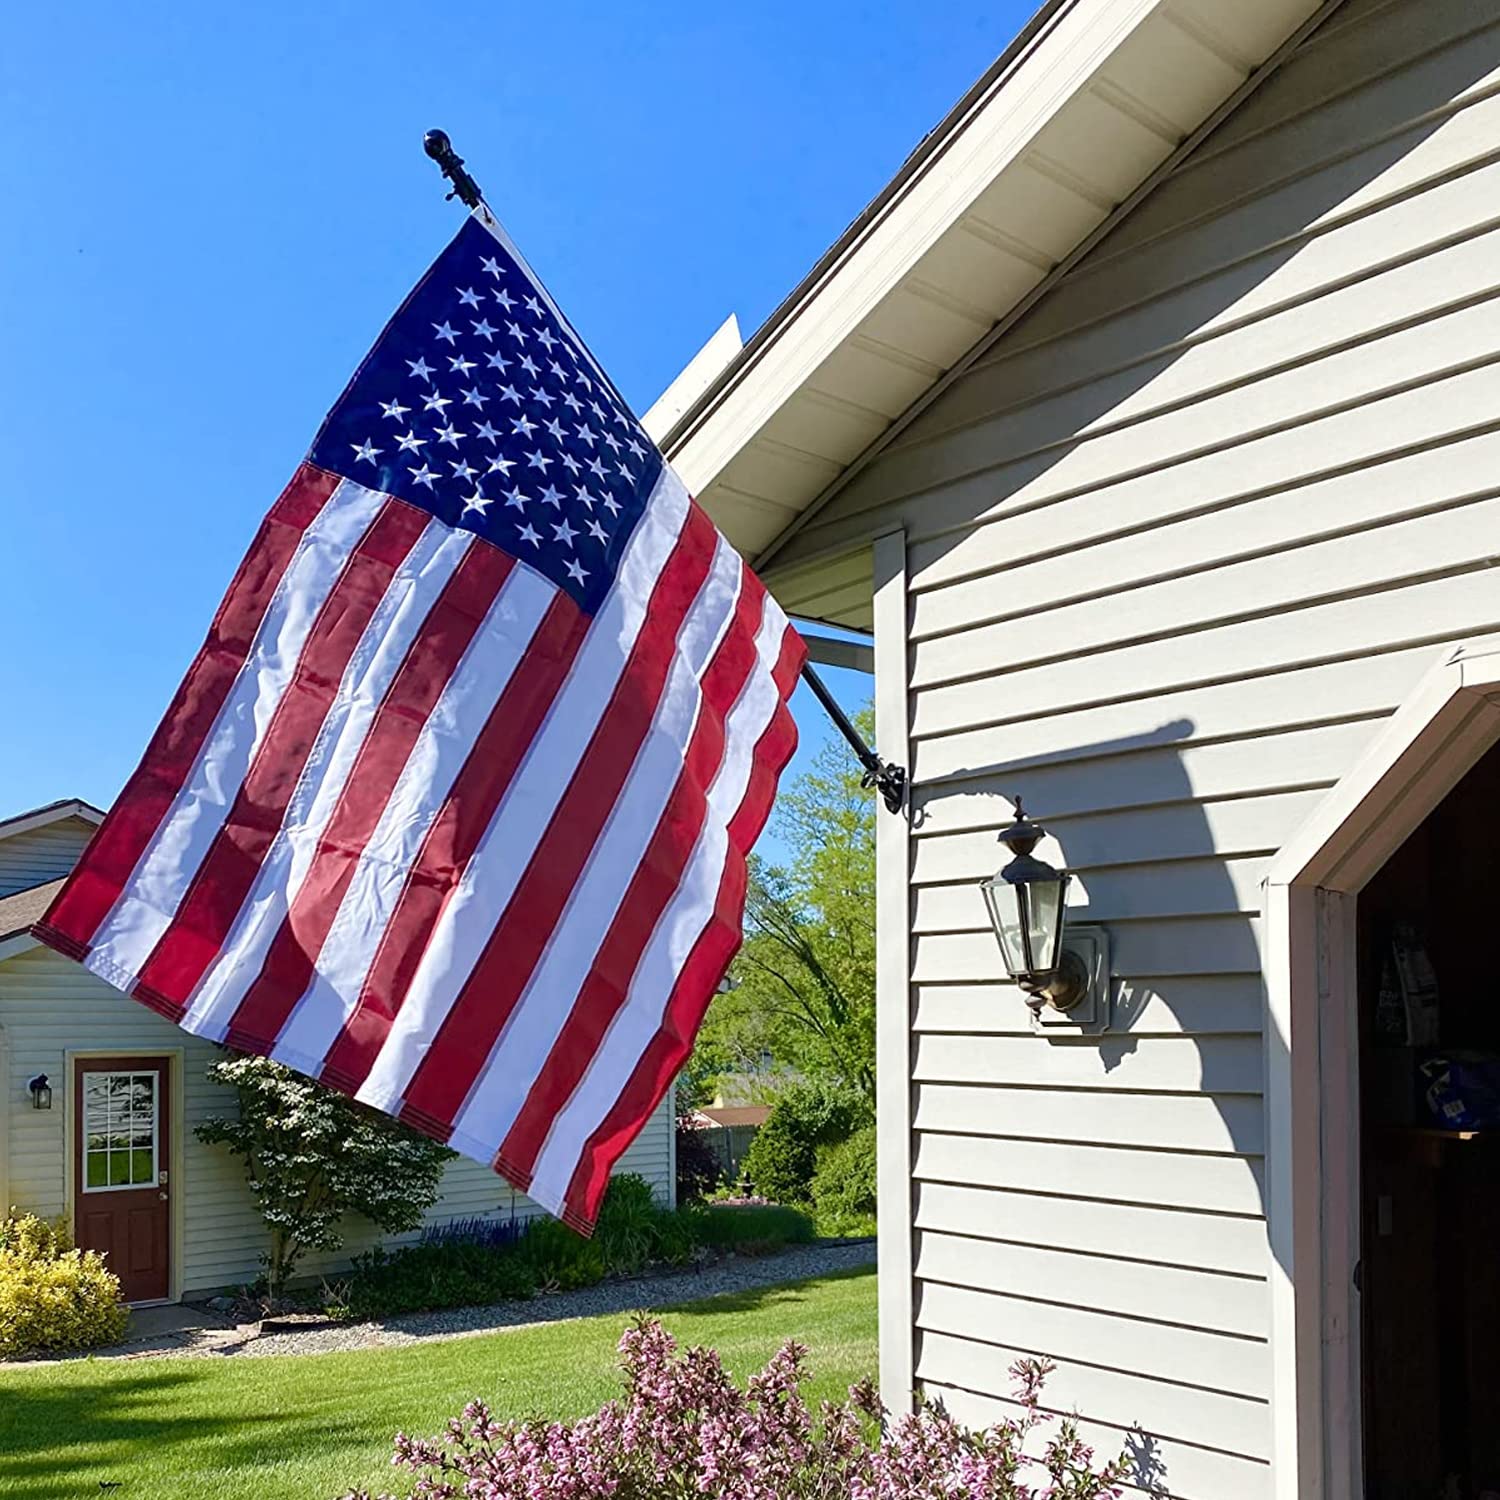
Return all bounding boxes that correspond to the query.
[86,480,387,989]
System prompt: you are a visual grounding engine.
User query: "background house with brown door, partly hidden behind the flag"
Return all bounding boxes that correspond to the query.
[0,801,674,1301]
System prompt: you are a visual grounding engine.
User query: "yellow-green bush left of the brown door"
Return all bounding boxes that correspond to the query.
[0,1214,129,1359]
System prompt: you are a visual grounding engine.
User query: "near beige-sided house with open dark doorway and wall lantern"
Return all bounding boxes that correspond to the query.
[657,0,1500,1500]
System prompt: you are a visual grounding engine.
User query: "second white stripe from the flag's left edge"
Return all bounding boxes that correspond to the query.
[182,521,474,1041]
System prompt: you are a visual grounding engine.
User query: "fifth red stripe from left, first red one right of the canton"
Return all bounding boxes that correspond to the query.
[401,506,719,1128]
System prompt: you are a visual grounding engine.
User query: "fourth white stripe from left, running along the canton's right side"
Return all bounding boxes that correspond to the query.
[356,470,689,1113]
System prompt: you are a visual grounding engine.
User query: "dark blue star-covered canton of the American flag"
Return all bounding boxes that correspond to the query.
[309,219,662,614]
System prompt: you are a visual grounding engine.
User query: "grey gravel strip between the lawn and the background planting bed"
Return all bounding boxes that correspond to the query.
[226,1239,875,1359]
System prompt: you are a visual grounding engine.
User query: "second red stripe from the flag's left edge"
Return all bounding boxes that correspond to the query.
[134,500,432,1011]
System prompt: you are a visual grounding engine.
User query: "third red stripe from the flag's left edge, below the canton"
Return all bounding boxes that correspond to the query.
[227,542,515,1053]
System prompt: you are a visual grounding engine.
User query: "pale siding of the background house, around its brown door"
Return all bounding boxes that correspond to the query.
[0,948,672,1296]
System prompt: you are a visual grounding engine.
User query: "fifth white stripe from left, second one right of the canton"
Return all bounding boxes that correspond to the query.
[449,537,744,1161]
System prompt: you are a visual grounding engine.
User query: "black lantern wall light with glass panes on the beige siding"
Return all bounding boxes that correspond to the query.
[980,798,1109,1031]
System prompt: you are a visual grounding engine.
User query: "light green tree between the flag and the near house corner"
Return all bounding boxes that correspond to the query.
[687,710,875,1106]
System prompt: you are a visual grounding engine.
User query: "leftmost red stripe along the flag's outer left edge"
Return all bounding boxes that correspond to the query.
[35,464,339,959]
